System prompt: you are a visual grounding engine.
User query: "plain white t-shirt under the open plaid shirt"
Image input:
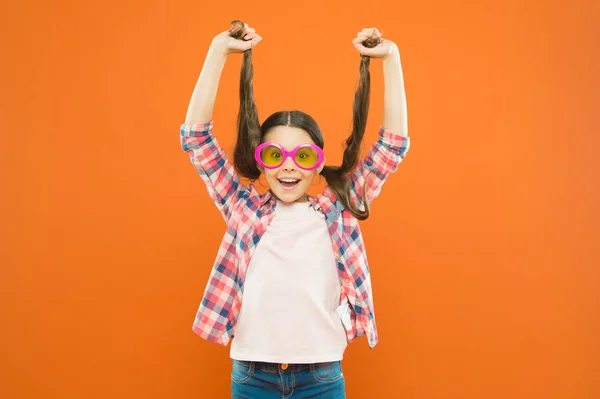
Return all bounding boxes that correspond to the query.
[230,201,347,363]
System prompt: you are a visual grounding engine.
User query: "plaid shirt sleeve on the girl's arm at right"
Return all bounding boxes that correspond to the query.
[350,127,410,209]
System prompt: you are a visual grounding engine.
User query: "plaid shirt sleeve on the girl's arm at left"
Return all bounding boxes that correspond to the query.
[180,121,247,222]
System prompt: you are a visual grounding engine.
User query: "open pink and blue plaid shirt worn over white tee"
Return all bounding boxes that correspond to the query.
[180,121,410,348]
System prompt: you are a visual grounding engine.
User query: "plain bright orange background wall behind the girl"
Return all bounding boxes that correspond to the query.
[0,0,600,399]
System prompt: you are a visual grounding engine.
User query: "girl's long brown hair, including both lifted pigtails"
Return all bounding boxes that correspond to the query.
[229,20,380,220]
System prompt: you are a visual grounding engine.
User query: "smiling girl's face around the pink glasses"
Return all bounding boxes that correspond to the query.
[261,126,325,202]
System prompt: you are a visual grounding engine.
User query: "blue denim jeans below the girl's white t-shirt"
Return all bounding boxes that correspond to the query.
[231,360,346,399]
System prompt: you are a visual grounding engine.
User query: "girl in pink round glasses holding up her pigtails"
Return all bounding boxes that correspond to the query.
[181,21,409,399]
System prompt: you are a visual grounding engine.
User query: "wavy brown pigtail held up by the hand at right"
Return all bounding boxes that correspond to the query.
[321,38,380,220]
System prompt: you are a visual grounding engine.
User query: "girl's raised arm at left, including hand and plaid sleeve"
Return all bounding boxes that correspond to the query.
[180,25,261,221]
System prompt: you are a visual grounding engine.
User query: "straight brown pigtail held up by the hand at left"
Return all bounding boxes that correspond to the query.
[229,20,261,180]
